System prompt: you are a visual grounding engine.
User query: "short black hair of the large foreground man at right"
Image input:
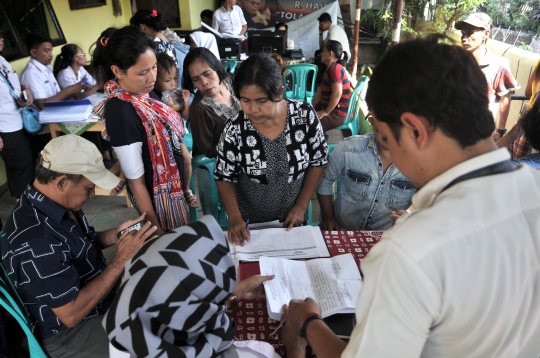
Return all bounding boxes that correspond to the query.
[366,35,495,148]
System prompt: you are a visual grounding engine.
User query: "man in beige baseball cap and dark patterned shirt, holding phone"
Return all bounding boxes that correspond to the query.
[1,135,156,357]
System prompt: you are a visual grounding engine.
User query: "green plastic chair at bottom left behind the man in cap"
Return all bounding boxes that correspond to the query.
[0,256,48,358]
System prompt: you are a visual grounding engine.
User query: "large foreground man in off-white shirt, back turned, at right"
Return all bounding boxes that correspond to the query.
[282,37,540,358]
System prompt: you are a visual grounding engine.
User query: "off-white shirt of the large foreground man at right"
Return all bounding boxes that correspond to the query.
[341,148,540,358]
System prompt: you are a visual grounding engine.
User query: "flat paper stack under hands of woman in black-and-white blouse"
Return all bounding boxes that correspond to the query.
[229,226,330,261]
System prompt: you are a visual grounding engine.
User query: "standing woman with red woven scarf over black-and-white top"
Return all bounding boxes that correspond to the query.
[92,26,189,234]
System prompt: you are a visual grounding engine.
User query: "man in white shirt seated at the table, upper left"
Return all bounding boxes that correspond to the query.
[21,33,82,109]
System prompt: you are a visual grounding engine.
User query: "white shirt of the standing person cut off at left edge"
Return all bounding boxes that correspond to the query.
[0,56,22,133]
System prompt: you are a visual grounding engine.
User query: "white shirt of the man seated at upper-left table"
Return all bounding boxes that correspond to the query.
[21,58,60,101]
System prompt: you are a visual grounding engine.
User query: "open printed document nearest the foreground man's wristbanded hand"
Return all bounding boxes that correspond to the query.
[259,254,362,321]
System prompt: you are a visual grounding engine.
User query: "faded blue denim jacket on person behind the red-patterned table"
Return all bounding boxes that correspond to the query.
[317,134,416,230]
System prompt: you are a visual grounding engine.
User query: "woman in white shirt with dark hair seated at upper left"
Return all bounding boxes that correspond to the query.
[53,44,100,99]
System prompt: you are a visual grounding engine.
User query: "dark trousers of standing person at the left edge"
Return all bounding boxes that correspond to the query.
[0,129,34,198]
